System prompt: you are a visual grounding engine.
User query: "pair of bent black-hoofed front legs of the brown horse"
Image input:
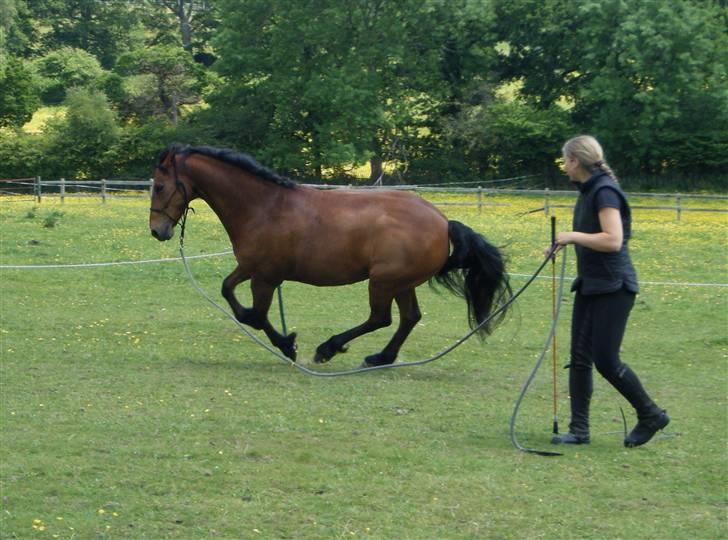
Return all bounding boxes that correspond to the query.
[221,266,296,361]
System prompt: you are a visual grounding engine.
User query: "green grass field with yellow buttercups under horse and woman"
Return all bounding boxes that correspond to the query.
[0,198,728,539]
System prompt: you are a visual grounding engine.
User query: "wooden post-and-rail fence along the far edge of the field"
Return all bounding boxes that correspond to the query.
[0,177,728,220]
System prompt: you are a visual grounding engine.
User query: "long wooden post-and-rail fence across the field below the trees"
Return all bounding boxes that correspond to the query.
[0,177,728,220]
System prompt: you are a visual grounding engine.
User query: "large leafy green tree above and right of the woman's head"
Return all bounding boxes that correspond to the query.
[574,0,728,174]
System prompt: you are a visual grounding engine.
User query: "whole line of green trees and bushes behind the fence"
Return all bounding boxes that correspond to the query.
[0,0,728,190]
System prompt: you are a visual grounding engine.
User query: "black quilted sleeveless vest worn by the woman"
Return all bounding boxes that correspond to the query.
[571,172,639,295]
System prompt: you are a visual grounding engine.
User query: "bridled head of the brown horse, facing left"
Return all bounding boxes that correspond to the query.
[149,146,192,241]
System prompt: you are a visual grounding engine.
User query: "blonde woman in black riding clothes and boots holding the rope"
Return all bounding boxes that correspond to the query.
[552,135,670,448]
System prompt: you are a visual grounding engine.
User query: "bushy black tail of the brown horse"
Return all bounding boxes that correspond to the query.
[432,221,513,337]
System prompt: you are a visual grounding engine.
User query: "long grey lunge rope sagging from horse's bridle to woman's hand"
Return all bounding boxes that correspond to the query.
[179,208,566,378]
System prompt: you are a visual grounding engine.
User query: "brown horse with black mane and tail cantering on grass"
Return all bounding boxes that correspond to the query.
[149,145,511,366]
